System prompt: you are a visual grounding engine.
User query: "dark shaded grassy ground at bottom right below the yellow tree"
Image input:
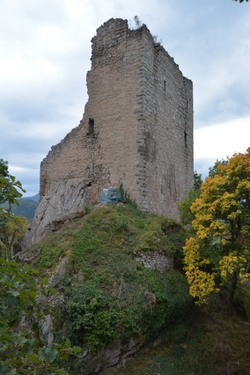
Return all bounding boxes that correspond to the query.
[102,287,250,375]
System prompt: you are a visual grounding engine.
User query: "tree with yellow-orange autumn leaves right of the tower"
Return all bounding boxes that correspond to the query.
[183,148,250,303]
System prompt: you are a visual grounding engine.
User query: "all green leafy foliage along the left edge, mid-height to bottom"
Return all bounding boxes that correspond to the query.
[0,159,79,375]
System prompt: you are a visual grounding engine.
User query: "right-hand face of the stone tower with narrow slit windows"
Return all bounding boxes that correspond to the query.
[137,33,193,219]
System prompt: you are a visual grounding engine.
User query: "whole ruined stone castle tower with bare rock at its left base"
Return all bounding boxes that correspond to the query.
[26,19,193,247]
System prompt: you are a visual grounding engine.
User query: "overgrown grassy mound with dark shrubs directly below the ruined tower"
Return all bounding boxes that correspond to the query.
[28,205,191,371]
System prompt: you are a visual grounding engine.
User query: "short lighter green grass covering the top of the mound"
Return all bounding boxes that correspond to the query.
[31,205,183,276]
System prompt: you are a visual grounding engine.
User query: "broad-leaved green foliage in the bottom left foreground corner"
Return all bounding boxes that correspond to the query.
[0,258,79,375]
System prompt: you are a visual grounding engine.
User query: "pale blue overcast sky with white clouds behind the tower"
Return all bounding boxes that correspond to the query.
[0,0,250,196]
